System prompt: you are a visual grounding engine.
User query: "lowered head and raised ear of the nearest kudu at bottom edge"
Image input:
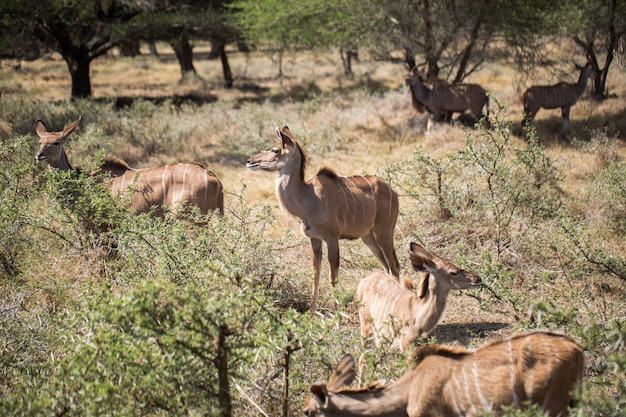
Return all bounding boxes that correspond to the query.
[304,354,356,417]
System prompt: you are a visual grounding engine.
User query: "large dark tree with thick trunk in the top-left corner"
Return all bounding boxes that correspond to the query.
[0,0,145,98]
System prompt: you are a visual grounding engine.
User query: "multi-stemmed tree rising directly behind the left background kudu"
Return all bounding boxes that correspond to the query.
[364,0,555,82]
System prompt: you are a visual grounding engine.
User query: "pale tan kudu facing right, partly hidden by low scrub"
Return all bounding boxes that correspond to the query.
[356,243,481,350]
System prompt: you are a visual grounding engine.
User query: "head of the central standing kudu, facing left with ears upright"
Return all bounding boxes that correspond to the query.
[246,126,304,175]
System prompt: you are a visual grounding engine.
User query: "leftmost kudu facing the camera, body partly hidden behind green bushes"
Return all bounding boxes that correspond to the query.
[35,117,224,217]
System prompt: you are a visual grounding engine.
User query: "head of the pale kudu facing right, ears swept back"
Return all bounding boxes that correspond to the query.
[409,243,481,298]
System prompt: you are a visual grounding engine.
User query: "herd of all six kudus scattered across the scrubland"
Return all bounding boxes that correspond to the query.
[35,66,594,417]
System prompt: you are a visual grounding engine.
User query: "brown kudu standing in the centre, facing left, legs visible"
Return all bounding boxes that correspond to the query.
[247,126,400,313]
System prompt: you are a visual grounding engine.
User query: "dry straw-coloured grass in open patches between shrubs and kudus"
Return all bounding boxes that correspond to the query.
[0,45,626,412]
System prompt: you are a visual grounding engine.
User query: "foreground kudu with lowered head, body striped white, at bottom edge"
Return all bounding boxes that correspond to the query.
[304,331,584,417]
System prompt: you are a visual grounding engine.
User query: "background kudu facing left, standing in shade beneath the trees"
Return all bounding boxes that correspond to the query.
[405,69,489,130]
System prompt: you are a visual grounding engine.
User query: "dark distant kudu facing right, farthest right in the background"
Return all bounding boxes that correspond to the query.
[523,64,596,128]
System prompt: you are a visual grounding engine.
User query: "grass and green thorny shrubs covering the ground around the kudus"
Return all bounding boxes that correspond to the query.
[0,2,626,416]
